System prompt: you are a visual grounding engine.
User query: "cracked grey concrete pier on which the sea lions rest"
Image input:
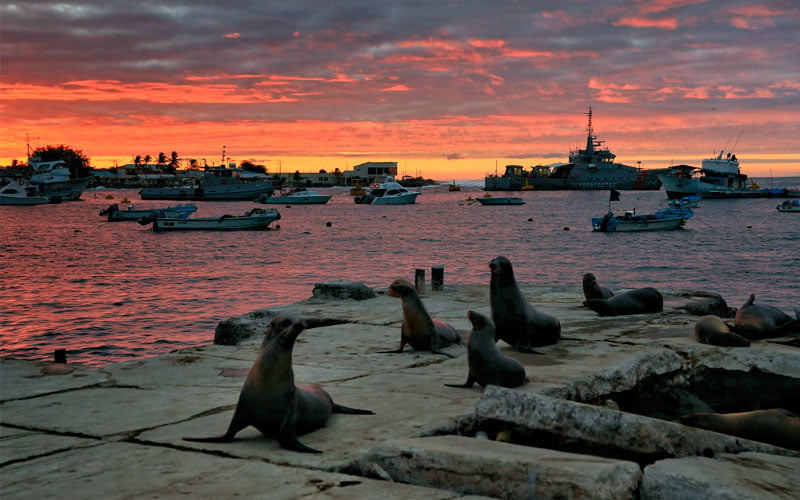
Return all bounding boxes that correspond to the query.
[0,283,800,500]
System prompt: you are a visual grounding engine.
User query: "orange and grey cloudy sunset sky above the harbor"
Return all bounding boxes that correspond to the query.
[0,0,800,180]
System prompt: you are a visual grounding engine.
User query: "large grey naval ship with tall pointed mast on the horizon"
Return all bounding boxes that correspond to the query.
[483,107,668,191]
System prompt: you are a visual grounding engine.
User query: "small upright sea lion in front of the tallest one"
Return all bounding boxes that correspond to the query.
[445,311,525,387]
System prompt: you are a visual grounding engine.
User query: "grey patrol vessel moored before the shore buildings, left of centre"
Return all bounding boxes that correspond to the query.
[139,166,275,201]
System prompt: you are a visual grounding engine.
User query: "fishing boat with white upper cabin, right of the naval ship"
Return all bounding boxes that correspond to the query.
[658,150,793,200]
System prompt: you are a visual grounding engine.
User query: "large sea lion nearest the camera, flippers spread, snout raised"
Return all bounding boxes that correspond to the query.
[183,316,373,453]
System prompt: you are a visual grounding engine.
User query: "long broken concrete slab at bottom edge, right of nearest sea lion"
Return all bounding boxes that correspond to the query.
[360,436,641,499]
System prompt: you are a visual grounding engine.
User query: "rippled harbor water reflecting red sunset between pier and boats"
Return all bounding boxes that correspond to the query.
[0,178,800,366]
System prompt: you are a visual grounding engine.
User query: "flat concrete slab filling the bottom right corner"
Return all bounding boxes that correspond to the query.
[641,453,800,500]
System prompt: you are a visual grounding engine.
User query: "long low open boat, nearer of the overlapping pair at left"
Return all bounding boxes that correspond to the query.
[138,208,281,232]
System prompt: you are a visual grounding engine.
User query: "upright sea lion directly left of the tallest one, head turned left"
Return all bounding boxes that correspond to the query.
[378,279,461,358]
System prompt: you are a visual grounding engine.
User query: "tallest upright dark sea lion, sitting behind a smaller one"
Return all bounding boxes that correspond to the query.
[489,255,561,354]
